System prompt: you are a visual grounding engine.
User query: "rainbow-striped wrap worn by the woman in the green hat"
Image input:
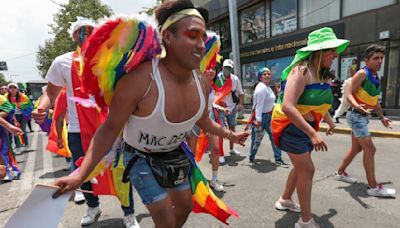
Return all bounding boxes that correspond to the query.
[271,78,333,146]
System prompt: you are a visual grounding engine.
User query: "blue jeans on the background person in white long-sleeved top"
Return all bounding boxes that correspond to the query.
[250,113,282,161]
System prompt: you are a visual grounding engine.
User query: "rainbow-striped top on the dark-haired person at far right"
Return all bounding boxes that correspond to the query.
[353,66,381,108]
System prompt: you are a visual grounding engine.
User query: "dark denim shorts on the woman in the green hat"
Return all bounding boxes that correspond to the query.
[279,121,314,154]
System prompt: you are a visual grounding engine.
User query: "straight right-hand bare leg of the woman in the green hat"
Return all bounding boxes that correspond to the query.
[288,153,315,221]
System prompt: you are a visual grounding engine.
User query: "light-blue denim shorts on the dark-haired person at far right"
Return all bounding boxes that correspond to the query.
[346,110,371,138]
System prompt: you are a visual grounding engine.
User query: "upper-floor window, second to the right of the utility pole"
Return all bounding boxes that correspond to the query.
[271,0,297,36]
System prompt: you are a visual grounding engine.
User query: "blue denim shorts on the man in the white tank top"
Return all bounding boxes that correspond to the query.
[124,151,190,205]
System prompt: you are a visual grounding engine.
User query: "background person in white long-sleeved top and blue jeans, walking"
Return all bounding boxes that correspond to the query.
[249,67,289,168]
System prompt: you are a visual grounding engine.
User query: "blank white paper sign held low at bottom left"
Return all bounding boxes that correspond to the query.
[4,185,72,228]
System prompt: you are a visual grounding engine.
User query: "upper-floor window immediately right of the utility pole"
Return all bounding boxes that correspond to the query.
[240,3,265,44]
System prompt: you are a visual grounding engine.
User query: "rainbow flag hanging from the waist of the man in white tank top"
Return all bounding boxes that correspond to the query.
[181,142,239,225]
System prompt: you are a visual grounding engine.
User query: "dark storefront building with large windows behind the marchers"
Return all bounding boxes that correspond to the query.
[193,0,400,116]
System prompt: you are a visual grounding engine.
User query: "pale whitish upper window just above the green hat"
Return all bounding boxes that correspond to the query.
[299,0,340,28]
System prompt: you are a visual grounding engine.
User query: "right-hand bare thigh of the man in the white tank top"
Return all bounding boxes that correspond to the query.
[169,189,193,228]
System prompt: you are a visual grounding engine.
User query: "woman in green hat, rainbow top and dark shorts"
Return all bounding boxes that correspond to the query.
[271,27,349,228]
